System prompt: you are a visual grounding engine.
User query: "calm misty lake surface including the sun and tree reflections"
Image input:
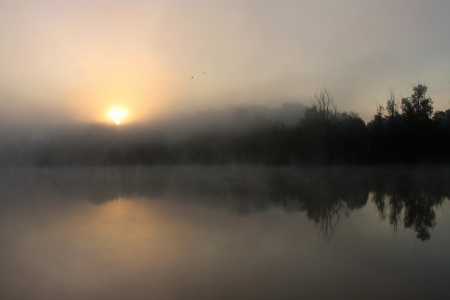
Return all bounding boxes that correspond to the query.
[0,166,450,299]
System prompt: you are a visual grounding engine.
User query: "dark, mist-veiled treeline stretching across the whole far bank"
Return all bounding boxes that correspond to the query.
[0,84,450,166]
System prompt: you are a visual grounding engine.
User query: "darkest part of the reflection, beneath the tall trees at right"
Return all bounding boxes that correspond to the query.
[269,168,449,241]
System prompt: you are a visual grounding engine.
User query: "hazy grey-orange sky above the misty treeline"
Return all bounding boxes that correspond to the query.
[0,0,450,126]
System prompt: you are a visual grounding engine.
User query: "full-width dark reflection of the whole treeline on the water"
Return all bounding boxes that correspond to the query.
[0,166,450,241]
